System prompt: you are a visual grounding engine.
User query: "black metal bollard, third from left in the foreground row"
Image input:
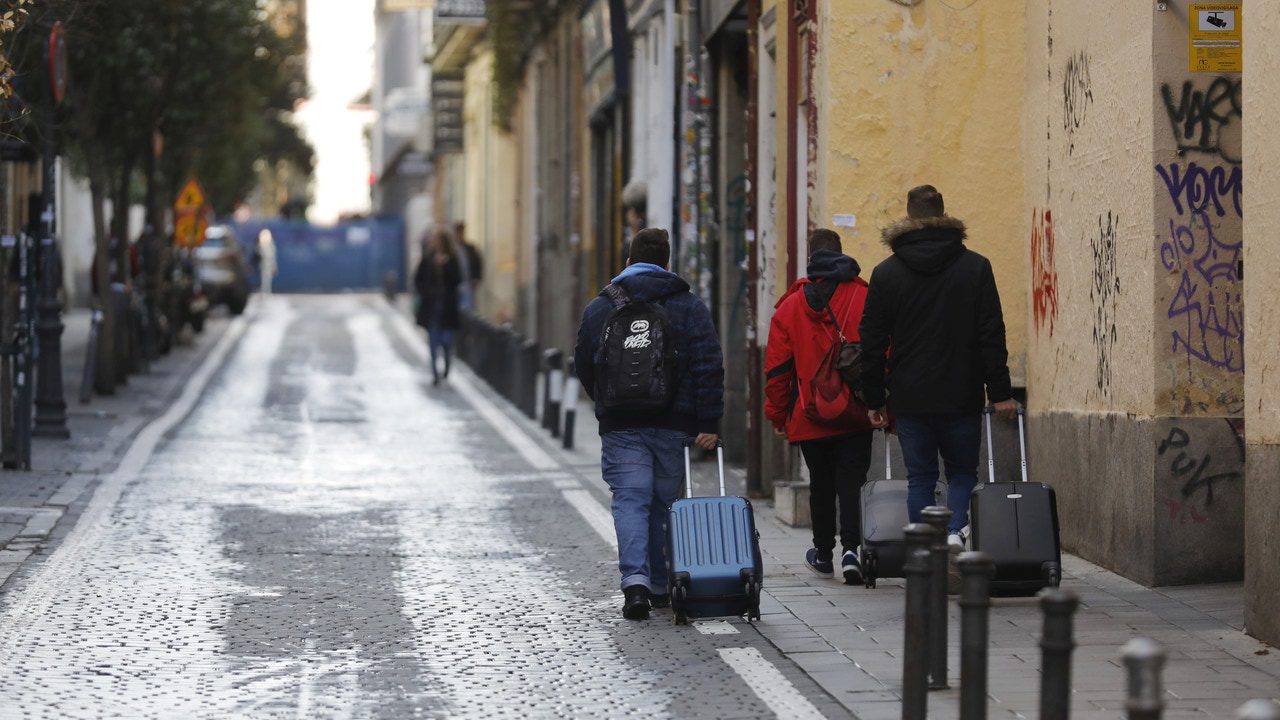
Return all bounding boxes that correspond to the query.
[956,552,996,720]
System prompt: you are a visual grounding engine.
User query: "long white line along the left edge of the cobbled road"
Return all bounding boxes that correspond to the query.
[0,318,247,645]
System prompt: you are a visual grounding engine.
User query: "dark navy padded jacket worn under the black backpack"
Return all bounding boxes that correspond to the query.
[573,272,724,434]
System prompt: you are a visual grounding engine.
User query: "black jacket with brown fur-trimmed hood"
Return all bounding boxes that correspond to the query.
[859,217,1012,415]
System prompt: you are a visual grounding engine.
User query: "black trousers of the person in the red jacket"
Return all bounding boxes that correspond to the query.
[800,432,872,560]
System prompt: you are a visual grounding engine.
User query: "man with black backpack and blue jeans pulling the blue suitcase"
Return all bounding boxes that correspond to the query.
[573,228,724,620]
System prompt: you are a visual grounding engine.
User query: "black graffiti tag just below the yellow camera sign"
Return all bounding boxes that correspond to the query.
[1160,77,1242,165]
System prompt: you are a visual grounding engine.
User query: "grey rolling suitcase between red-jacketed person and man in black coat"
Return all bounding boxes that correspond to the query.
[858,430,908,588]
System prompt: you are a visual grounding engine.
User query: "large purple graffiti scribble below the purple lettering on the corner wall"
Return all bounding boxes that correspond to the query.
[1160,213,1244,373]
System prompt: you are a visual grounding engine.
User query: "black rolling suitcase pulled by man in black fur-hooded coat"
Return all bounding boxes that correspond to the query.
[969,407,1062,594]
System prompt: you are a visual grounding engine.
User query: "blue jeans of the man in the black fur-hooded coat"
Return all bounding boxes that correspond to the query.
[897,414,982,533]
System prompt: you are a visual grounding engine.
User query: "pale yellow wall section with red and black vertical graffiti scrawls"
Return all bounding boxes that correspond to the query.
[1018,0,1157,415]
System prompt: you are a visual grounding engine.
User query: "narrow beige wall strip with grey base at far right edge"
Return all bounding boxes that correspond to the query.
[1244,1,1280,644]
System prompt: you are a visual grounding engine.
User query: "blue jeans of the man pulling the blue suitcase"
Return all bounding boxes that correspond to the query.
[600,428,689,594]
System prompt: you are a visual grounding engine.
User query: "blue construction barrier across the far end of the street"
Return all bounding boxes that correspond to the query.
[233,218,408,292]
